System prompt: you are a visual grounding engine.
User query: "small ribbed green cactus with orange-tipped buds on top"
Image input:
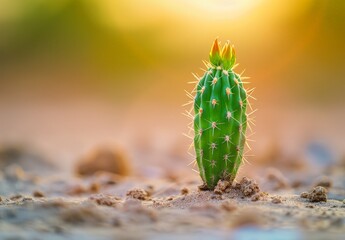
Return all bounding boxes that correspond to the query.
[194,39,247,189]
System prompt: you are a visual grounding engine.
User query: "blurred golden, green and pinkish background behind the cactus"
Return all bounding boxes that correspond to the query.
[0,0,345,176]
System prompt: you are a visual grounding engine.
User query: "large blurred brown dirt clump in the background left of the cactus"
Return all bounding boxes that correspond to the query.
[76,147,130,176]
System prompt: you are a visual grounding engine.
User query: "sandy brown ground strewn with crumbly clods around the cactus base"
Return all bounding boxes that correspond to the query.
[0,145,345,239]
